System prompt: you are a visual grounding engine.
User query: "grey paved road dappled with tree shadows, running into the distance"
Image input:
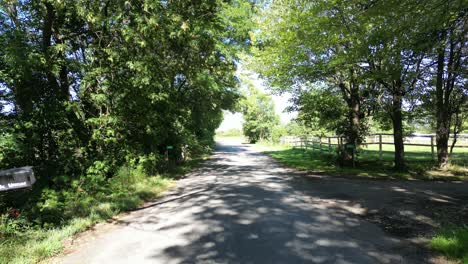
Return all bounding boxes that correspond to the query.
[60,141,464,264]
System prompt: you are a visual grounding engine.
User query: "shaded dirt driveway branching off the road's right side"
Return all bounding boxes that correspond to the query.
[282,167,468,263]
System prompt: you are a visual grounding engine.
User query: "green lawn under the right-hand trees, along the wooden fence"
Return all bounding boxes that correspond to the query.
[257,143,468,180]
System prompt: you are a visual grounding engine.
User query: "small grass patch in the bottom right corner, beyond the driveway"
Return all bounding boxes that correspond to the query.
[431,226,468,264]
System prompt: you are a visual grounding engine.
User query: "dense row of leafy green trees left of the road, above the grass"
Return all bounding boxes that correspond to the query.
[0,0,252,187]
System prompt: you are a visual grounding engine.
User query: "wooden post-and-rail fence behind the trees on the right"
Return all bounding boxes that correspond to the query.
[280,134,468,160]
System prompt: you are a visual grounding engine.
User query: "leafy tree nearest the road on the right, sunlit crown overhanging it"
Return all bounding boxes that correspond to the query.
[250,1,369,150]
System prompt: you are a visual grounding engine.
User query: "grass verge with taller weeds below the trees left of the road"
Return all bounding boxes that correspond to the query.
[0,156,206,263]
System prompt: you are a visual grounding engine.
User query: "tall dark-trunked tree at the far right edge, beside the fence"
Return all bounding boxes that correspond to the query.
[428,1,468,168]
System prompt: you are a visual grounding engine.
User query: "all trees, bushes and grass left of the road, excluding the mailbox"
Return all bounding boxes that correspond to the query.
[0,0,253,263]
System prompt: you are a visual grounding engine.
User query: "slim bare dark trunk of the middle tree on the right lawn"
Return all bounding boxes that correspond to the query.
[392,83,405,170]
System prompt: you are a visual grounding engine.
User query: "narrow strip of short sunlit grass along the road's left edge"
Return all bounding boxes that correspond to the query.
[0,176,173,263]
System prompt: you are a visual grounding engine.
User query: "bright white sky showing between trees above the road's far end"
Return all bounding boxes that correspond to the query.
[217,67,297,131]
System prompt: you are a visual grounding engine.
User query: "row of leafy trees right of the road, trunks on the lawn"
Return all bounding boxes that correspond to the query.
[250,0,468,169]
